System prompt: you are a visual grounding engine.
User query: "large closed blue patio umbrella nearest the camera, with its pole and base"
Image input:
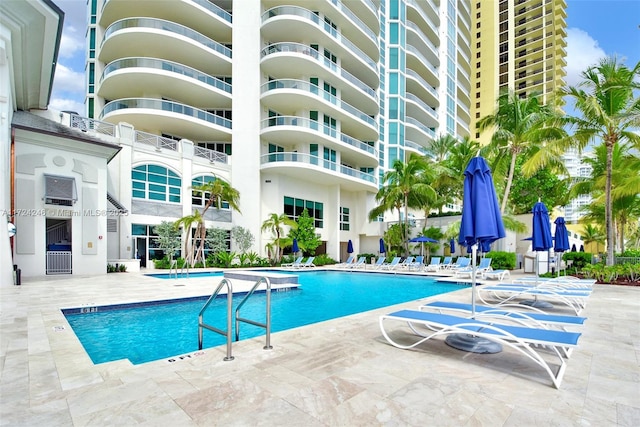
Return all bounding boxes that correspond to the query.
[446,156,506,353]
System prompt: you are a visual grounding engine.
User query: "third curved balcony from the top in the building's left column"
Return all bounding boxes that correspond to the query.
[98,58,231,109]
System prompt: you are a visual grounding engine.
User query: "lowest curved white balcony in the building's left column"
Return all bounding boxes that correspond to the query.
[100,98,232,141]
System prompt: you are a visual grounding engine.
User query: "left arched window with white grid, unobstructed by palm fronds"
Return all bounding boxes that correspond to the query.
[131,165,182,203]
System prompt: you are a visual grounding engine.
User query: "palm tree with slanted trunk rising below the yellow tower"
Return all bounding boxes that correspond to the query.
[477,92,565,214]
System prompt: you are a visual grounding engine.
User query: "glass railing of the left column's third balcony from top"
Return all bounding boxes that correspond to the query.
[100,58,231,94]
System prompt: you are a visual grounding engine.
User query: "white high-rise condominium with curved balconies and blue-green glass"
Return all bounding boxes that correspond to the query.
[86,0,470,266]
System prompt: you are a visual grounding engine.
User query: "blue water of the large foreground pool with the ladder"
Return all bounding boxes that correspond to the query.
[63,271,460,364]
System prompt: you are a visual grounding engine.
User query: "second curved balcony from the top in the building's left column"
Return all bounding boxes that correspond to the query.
[104,18,231,75]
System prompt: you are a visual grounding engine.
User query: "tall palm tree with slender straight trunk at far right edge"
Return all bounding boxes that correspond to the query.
[564,57,640,265]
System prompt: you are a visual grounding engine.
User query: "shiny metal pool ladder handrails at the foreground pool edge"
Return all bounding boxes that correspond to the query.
[198,277,273,361]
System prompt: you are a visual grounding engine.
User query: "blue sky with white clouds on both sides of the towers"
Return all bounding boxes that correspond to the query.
[46,0,640,115]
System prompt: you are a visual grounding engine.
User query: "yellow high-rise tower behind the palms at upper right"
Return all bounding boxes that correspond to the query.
[471,0,567,142]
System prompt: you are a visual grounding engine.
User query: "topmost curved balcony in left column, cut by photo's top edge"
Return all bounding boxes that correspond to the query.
[100,0,232,41]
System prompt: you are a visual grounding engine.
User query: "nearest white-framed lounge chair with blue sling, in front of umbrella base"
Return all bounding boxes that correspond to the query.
[379,310,580,388]
